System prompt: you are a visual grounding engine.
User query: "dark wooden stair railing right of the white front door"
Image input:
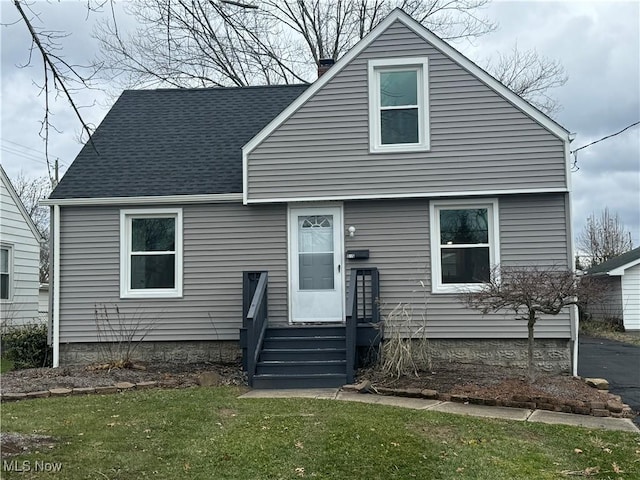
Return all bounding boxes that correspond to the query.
[346,267,380,383]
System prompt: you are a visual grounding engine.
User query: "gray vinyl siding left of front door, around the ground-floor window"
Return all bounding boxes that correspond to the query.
[60,204,287,343]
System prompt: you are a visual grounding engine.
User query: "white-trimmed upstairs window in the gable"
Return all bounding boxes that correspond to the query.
[369,57,430,153]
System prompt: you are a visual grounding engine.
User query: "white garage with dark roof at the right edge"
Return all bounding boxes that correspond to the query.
[587,247,640,331]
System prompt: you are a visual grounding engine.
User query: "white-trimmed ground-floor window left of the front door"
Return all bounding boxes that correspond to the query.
[120,208,182,298]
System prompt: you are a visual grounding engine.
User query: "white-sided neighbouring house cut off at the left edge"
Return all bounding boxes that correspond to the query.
[0,166,42,327]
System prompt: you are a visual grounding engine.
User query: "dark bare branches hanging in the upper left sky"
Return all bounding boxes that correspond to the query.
[13,0,104,183]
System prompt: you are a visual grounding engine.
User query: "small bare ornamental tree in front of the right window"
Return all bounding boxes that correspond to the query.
[462,266,602,381]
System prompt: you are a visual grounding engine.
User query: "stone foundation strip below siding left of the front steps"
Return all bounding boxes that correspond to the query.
[60,340,242,365]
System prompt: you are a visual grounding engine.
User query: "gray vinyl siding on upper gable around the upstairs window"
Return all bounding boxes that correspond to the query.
[247,23,566,201]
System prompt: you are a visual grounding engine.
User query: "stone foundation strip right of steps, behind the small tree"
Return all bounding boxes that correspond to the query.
[410,339,571,373]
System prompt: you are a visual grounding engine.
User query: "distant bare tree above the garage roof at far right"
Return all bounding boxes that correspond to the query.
[578,207,633,267]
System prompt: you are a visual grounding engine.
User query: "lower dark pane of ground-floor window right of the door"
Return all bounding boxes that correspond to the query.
[440,247,491,283]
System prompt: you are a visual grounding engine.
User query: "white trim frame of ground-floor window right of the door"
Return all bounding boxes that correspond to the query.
[429,198,500,293]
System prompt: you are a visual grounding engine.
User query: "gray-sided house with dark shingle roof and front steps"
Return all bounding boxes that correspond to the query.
[47,10,577,386]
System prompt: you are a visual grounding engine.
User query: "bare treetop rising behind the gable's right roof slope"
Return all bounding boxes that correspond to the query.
[486,44,568,115]
